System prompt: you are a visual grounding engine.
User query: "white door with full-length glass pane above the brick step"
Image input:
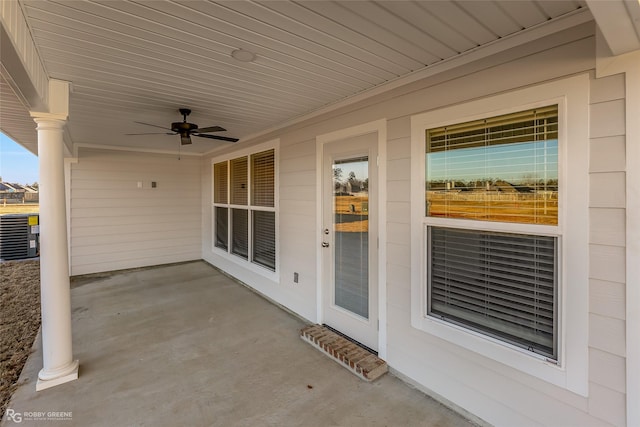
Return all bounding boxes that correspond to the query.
[322,133,378,350]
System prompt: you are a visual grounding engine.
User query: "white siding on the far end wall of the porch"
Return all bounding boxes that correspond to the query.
[69,148,202,275]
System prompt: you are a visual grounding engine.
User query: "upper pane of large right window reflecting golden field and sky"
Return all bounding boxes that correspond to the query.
[426,106,558,225]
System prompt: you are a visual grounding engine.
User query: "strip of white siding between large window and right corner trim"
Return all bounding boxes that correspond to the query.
[589,74,629,425]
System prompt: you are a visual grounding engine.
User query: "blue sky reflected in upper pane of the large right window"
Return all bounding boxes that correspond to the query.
[426,139,558,183]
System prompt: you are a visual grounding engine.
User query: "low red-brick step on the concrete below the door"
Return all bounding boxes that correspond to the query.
[300,325,388,381]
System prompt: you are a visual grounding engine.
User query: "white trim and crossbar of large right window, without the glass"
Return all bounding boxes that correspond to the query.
[411,74,589,396]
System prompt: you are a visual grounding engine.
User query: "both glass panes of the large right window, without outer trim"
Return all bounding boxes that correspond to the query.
[425,105,558,360]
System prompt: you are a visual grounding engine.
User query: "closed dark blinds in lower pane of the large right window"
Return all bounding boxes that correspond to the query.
[428,227,557,359]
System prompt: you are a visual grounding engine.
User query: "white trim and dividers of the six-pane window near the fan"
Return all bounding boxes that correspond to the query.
[209,139,280,283]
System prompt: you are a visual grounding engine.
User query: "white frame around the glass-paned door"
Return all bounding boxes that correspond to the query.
[316,119,387,359]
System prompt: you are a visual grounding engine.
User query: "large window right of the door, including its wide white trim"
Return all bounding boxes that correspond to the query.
[411,74,589,396]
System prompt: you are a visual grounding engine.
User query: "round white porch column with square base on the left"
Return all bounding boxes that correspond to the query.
[32,113,78,391]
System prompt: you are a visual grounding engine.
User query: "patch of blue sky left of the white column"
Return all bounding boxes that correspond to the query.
[0,132,39,184]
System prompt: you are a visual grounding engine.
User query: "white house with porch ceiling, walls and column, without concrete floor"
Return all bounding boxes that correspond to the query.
[0,0,640,426]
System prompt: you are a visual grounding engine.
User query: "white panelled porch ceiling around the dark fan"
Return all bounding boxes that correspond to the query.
[0,0,586,153]
